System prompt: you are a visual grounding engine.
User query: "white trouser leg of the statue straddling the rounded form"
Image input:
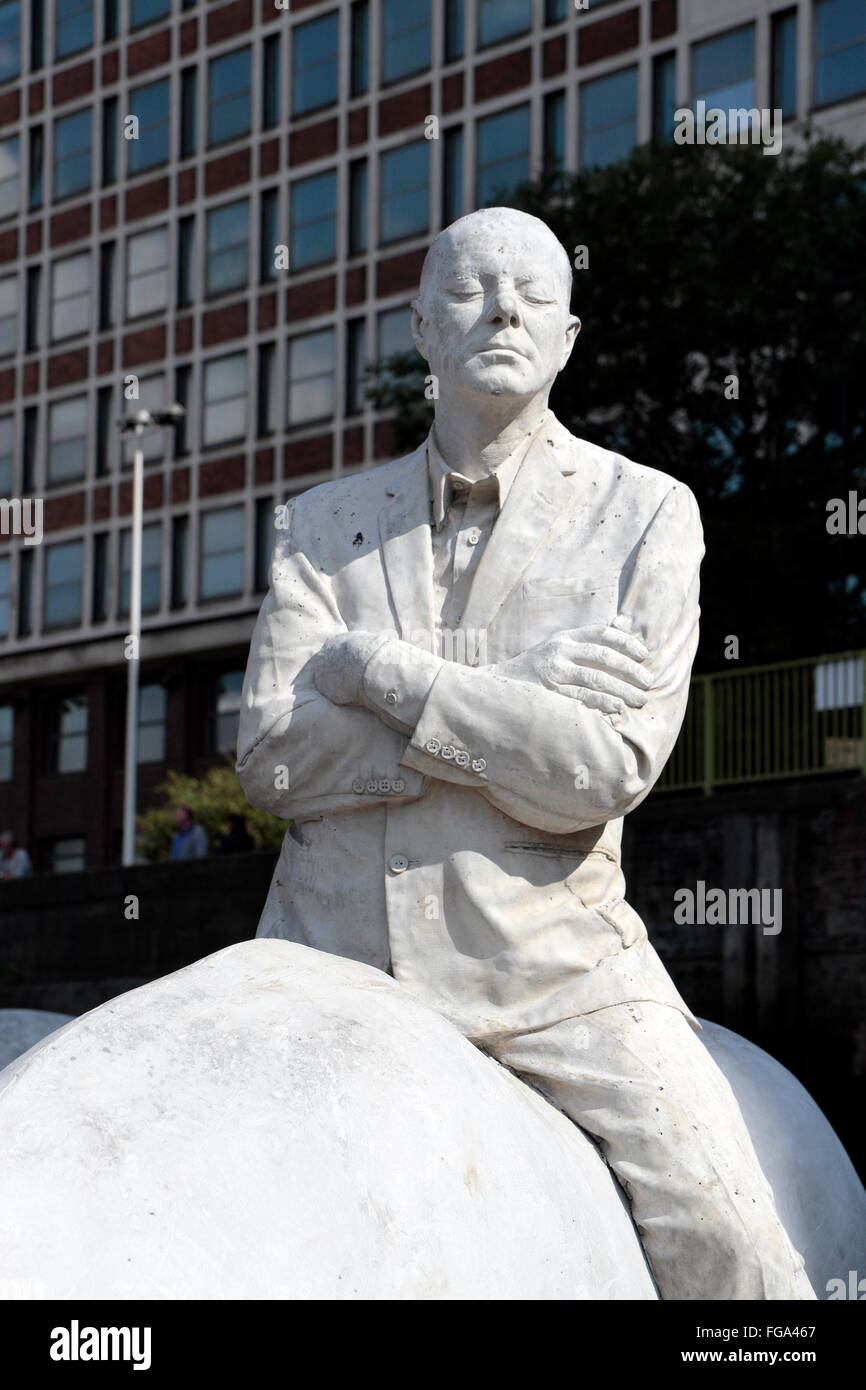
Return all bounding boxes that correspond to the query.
[484,1002,815,1300]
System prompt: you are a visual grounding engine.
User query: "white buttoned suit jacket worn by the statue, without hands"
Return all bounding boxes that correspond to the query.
[238,416,703,1040]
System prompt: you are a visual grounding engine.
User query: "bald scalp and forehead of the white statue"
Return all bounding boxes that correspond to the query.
[418,207,571,309]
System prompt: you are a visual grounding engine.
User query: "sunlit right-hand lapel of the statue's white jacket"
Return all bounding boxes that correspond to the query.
[461,420,571,644]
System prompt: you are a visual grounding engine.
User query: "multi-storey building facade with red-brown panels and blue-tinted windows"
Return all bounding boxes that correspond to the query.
[0,0,866,870]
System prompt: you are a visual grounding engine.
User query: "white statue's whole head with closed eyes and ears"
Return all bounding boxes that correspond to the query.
[411,207,580,402]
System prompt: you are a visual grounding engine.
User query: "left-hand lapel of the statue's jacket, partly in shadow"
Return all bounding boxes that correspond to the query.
[379,442,434,641]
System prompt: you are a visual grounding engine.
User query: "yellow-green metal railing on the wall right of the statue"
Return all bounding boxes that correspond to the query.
[656,652,866,792]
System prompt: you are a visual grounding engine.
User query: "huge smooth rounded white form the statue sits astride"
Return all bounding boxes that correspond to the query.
[0,940,866,1300]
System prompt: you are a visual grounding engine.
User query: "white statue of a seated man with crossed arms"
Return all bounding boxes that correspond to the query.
[238,207,815,1300]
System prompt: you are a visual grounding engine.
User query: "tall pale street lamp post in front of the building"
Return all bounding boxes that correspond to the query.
[117,403,186,866]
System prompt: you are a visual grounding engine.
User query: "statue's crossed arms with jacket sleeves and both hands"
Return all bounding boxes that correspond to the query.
[238,485,703,834]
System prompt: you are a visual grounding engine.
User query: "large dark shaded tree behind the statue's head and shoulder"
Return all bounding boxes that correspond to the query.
[369,131,866,670]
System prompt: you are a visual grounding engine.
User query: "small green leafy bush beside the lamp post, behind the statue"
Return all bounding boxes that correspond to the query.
[138,759,289,860]
